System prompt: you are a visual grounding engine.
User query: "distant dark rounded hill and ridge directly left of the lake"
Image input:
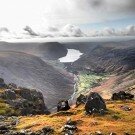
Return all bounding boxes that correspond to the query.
[0,42,67,60]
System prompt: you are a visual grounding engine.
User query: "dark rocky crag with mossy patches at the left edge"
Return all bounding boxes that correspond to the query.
[0,80,49,115]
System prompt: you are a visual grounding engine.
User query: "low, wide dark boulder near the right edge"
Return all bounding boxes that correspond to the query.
[111,91,134,100]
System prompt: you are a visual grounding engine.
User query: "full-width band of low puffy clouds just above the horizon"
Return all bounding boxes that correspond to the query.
[0,24,135,39]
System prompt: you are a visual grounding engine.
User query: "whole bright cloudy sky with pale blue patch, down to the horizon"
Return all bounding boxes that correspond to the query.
[0,0,135,38]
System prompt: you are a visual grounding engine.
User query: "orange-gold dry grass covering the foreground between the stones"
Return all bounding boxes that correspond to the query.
[16,101,135,135]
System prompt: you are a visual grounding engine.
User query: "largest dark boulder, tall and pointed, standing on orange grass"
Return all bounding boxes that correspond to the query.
[85,92,106,114]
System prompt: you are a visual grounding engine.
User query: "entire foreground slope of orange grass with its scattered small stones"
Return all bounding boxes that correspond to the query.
[0,95,135,135]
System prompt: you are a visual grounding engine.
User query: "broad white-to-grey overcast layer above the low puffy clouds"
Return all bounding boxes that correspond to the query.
[0,0,135,29]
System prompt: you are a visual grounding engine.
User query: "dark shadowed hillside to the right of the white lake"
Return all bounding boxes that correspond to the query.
[65,41,135,73]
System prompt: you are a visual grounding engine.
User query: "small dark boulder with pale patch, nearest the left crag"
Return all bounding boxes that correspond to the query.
[57,100,70,112]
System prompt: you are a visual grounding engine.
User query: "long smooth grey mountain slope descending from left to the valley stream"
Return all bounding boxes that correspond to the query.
[0,51,74,108]
